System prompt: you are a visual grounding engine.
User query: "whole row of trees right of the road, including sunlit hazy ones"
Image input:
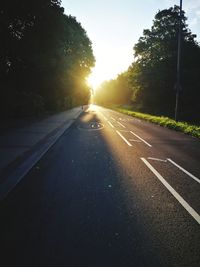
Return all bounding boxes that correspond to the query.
[95,6,200,121]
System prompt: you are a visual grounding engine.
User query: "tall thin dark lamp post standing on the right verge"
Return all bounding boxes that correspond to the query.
[175,0,182,121]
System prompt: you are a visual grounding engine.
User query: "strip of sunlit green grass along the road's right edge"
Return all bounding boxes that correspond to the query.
[114,108,200,138]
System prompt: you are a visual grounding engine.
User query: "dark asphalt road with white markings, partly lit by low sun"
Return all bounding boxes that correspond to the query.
[0,106,200,267]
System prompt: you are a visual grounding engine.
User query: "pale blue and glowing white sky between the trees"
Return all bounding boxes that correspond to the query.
[62,0,200,89]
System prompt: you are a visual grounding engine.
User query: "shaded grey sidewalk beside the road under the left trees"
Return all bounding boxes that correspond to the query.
[0,107,82,175]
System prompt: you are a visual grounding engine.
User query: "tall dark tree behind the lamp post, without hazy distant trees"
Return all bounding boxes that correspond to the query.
[130,6,200,120]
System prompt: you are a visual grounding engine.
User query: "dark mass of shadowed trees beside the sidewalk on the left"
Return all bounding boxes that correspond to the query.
[0,0,95,116]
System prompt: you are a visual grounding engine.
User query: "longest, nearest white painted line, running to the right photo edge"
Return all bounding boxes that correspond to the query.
[141,158,200,224]
